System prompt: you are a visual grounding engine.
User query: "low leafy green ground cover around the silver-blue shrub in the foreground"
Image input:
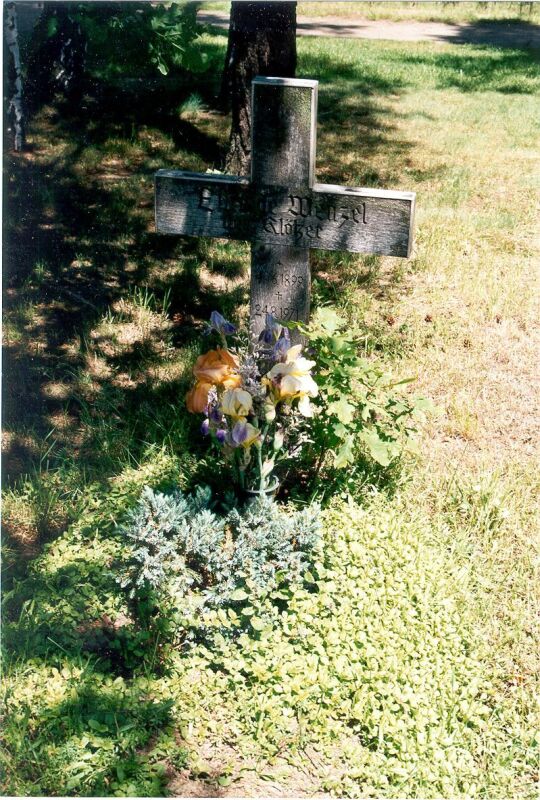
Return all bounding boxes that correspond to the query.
[5,472,537,798]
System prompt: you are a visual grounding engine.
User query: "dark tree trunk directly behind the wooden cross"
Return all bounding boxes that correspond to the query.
[220,0,296,175]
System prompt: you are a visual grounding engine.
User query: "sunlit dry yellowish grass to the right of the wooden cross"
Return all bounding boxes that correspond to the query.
[302,43,540,469]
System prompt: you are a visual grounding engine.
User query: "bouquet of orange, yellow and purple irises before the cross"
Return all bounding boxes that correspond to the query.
[186,311,318,492]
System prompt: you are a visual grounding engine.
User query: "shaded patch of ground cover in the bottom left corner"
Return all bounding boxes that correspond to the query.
[4,672,175,797]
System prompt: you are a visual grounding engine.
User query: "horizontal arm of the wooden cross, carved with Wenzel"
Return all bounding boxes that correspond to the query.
[156,170,415,257]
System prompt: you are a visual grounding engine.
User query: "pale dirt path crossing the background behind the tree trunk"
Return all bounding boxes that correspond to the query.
[197,11,540,49]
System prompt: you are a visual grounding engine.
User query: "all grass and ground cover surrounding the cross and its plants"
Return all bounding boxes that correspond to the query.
[1,37,538,798]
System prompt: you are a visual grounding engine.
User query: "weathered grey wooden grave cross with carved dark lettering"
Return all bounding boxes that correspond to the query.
[155,77,415,335]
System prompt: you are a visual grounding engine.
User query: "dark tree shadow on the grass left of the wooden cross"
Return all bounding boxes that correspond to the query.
[4,65,251,488]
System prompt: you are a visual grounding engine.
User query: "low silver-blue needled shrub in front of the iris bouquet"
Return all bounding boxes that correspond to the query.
[119,487,321,607]
